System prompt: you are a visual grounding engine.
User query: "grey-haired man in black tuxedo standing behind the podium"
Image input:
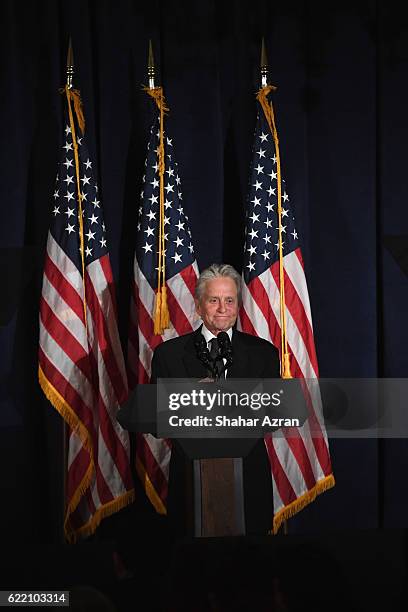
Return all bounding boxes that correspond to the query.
[151,264,280,534]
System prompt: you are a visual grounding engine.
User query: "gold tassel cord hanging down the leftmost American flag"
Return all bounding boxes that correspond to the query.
[64,85,87,328]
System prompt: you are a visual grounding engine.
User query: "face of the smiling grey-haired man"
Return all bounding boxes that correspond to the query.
[195,276,238,336]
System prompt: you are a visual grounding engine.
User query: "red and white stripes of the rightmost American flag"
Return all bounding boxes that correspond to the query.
[239,249,334,531]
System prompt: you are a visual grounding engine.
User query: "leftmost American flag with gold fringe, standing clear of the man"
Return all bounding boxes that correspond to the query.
[39,91,134,541]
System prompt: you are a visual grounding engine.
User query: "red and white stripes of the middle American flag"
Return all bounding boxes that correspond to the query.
[128,257,200,514]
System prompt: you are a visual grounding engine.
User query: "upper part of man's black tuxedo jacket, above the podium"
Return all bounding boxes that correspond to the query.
[151,327,280,382]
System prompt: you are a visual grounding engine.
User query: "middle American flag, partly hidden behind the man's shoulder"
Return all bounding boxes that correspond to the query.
[128,103,199,514]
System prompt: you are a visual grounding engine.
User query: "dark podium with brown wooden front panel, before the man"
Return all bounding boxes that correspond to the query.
[117,385,257,537]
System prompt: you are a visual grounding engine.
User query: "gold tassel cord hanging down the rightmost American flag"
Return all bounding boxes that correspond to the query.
[256,85,292,378]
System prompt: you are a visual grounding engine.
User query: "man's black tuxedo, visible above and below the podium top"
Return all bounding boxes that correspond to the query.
[151,328,280,535]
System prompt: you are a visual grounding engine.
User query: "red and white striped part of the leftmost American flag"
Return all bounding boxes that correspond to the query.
[39,233,133,540]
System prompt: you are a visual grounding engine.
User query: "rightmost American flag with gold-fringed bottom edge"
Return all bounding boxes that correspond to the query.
[239,88,334,533]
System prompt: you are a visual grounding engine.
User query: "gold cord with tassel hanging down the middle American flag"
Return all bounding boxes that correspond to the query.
[143,87,170,334]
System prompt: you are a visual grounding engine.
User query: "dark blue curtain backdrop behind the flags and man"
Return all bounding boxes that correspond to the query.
[0,0,408,540]
